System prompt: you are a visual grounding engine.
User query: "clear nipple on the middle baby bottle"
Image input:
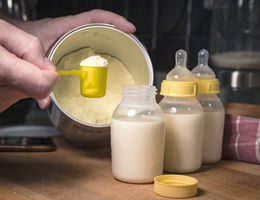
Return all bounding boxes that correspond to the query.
[166,50,194,81]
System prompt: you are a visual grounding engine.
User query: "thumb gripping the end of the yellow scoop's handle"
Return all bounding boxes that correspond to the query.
[0,46,59,99]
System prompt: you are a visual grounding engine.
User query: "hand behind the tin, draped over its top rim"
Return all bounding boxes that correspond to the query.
[18,9,136,51]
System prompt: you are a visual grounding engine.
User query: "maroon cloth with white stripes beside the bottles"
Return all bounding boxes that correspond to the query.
[222,115,260,164]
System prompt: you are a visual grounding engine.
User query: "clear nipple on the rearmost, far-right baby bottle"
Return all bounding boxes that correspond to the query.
[191,49,216,79]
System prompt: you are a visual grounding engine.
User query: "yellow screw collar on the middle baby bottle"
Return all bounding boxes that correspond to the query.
[160,80,197,97]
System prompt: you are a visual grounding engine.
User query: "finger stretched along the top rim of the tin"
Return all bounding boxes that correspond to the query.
[74,9,136,33]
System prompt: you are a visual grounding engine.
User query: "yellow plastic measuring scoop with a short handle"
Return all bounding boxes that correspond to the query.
[57,66,107,98]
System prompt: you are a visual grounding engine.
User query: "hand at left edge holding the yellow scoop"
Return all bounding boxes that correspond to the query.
[0,19,59,112]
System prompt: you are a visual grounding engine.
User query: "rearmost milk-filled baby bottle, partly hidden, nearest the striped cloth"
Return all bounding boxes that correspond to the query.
[192,49,225,164]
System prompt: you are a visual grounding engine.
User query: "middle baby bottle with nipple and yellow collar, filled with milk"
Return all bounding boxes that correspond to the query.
[159,50,204,173]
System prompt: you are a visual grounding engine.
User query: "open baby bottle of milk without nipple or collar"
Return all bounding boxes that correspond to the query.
[111,86,165,183]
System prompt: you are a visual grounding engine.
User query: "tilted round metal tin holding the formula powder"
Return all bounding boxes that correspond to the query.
[48,24,153,146]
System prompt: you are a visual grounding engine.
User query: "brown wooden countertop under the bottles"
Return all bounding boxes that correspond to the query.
[0,138,260,200]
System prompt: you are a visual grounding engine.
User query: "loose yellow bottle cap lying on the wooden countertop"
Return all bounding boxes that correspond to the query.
[154,175,198,198]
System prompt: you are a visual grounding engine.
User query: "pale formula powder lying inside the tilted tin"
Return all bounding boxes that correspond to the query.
[54,48,135,124]
